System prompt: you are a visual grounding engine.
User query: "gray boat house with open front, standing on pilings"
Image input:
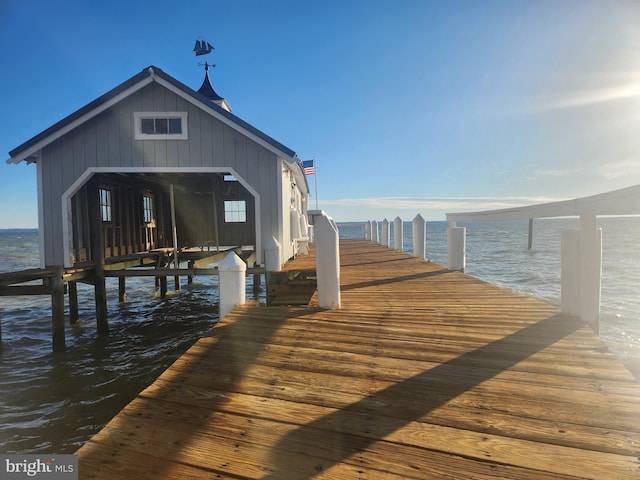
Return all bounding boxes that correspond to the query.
[7,66,309,268]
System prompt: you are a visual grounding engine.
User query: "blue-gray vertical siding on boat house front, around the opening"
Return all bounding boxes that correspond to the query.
[40,82,280,265]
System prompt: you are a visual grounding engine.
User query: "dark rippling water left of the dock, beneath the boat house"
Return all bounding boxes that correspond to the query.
[0,231,245,453]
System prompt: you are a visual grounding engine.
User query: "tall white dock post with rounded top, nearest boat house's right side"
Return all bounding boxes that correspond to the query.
[309,210,340,309]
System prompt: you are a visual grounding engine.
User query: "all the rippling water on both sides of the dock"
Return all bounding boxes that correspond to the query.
[0,218,640,453]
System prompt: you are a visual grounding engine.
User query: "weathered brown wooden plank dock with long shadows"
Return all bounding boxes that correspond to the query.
[78,240,640,480]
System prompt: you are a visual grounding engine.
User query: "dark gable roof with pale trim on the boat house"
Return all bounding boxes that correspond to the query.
[7,65,298,163]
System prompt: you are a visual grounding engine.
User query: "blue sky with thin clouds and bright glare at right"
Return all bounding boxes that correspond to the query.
[0,0,640,228]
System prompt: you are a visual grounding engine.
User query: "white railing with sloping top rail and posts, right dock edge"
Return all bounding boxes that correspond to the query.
[447,185,640,332]
